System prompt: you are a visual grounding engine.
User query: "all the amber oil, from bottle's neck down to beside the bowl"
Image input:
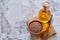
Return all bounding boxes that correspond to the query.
[38,10,51,32]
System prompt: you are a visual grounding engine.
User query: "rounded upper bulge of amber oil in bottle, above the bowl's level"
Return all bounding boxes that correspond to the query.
[38,11,51,23]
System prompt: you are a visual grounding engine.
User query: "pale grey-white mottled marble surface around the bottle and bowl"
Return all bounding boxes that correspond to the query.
[0,0,60,40]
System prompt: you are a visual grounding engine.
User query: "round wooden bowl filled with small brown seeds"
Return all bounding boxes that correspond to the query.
[28,20,43,35]
